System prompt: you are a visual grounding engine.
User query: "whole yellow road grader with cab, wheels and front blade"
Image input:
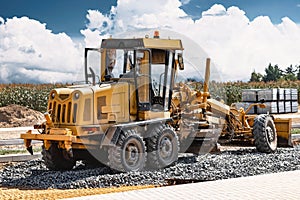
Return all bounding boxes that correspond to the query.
[20,32,290,171]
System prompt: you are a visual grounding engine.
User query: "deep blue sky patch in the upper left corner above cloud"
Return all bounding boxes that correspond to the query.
[0,0,116,36]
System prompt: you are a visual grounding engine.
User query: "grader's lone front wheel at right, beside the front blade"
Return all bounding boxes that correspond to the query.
[253,114,277,153]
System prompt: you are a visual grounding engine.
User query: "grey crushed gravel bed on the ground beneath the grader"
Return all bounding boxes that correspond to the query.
[0,148,300,189]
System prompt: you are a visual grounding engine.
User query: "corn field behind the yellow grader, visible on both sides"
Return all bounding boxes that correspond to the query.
[0,80,300,112]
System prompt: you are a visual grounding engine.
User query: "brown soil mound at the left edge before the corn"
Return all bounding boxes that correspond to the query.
[0,104,44,128]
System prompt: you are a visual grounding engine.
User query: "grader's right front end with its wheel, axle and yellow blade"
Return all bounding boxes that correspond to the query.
[219,103,292,153]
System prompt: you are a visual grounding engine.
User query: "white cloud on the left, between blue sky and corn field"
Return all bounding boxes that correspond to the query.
[0,17,82,83]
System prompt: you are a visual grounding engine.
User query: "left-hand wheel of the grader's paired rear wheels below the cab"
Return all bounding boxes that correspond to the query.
[108,129,147,172]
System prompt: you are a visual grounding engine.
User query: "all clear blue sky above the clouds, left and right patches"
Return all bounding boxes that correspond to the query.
[0,0,300,36]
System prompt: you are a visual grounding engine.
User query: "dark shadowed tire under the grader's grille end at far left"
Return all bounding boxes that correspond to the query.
[42,143,76,171]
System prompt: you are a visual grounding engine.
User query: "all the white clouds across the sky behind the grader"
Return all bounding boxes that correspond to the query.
[0,0,300,82]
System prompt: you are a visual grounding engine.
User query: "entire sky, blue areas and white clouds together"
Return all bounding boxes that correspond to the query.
[0,0,300,83]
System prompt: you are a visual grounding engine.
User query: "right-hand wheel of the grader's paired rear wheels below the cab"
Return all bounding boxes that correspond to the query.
[146,124,179,169]
